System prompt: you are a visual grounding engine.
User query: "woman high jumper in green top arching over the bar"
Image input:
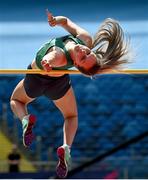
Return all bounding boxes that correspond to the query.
[10,10,129,178]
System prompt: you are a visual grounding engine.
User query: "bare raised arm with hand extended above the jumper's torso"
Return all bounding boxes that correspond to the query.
[47,10,92,48]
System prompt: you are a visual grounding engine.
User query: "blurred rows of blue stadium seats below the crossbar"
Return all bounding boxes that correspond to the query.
[0,75,148,174]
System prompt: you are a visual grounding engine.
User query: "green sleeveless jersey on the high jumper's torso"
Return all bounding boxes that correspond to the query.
[35,35,84,70]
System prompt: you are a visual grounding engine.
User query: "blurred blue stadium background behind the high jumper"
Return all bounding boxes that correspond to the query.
[0,0,148,179]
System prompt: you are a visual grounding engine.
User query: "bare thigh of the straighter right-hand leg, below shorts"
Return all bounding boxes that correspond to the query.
[53,87,78,117]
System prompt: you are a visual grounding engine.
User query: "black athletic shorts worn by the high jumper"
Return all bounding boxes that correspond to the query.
[24,65,71,100]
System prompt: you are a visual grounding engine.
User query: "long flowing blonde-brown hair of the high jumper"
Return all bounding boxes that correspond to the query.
[93,18,129,71]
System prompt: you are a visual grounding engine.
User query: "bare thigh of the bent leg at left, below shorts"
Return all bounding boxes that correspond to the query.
[11,79,34,103]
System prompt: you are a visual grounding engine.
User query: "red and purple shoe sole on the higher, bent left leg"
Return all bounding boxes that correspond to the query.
[23,115,36,147]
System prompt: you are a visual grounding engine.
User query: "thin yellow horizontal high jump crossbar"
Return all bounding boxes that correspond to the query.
[0,69,148,75]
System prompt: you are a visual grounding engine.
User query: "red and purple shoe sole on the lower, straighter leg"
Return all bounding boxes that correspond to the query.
[56,147,68,178]
